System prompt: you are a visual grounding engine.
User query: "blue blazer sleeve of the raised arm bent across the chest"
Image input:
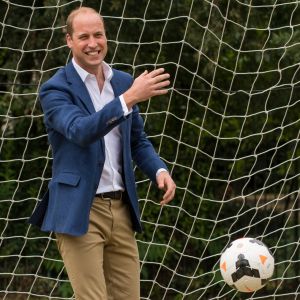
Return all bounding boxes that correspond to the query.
[39,76,126,147]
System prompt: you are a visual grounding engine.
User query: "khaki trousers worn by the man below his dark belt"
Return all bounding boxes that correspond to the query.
[56,197,140,300]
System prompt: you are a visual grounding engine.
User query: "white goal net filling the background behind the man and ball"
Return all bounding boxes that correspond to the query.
[0,0,300,300]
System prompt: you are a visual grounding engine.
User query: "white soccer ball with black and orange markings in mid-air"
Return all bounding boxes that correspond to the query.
[220,238,274,293]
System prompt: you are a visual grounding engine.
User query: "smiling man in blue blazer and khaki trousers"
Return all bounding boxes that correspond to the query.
[30,7,176,300]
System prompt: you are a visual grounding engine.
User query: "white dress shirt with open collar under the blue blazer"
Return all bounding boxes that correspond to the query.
[72,58,166,194]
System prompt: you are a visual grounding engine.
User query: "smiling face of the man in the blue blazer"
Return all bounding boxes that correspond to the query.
[67,12,107,74]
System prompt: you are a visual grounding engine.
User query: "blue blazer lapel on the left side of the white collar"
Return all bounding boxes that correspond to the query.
[65,62,95,114]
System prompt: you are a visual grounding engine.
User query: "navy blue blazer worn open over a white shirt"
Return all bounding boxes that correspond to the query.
[29,62,167,236]
